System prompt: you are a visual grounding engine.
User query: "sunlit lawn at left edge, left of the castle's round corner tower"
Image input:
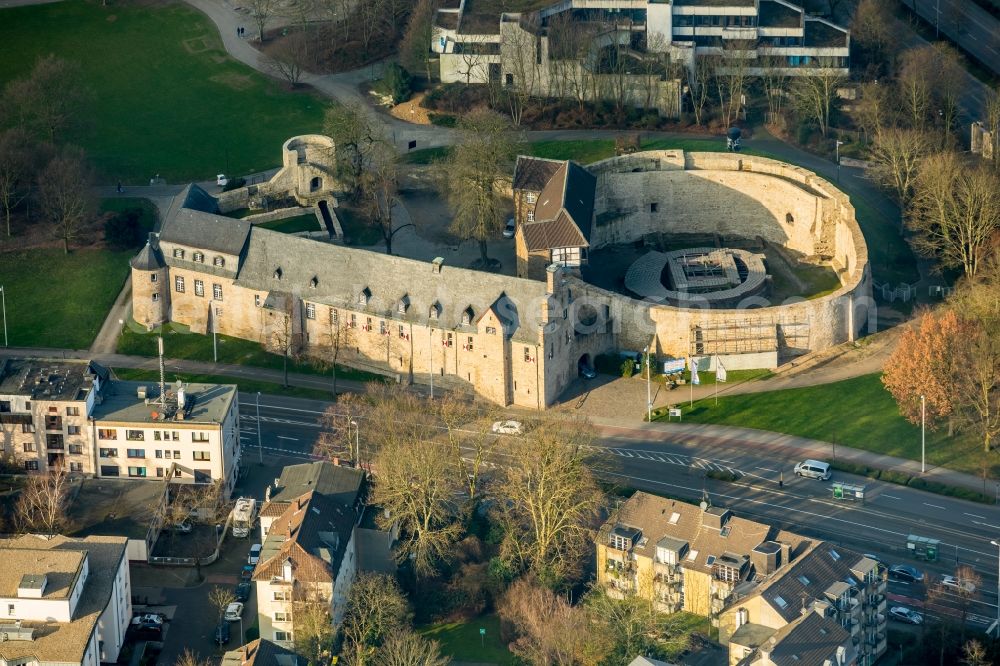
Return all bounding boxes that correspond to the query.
[0,249,135,349]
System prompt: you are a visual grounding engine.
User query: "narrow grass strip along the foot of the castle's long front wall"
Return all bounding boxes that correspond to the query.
[117,322,381,381]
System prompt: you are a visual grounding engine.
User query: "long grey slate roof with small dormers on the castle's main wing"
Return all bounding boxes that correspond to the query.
[236,227,546,342]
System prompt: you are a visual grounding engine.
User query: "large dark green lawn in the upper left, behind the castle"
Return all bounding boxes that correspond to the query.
[0,0,325,184]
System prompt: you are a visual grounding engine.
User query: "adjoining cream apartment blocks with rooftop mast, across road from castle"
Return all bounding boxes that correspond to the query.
[0,359,240,490]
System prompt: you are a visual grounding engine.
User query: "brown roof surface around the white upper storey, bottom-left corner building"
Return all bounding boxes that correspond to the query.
[0,535,128,664]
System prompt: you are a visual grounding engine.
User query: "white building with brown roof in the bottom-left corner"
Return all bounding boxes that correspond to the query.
[0,535,132,666]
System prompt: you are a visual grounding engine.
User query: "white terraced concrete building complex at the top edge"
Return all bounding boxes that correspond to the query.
[430,0,850,93]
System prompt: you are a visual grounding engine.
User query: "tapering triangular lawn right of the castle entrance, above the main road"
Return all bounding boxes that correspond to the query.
[653,373,1000,477]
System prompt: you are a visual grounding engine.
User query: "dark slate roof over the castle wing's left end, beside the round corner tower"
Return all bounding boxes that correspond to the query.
[160,183,252,256]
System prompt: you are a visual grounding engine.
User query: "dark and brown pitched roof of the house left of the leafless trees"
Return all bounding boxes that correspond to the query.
[253,492,357,583]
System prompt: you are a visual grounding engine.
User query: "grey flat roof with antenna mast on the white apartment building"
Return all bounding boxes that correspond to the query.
[93,380,236,425]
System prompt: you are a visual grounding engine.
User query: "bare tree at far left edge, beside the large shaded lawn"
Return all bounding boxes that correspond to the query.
[3,55,90,142]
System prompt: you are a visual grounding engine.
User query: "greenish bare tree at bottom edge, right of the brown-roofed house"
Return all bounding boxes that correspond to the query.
[341,573,410,666]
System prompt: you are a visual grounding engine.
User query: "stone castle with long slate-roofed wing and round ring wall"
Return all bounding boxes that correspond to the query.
[132,139,873,409]
